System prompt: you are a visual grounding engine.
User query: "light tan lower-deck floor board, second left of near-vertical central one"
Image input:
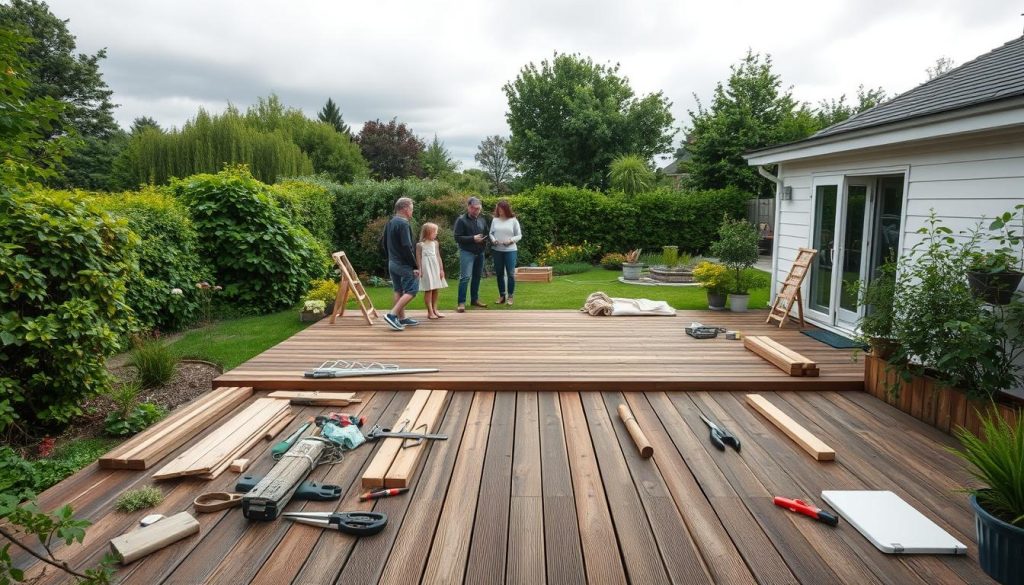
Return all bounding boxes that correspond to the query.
[417,392,495,584]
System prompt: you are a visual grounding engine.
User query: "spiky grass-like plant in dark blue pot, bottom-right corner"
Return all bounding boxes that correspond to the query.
[953,414,1024,585]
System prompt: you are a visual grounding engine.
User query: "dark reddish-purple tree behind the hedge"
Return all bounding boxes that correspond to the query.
[356,118,426,179]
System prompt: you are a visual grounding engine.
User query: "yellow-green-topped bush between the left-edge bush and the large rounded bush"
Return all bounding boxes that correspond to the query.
[93,187,210,331]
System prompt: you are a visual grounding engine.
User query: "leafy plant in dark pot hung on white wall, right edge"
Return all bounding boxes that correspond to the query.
[967,204,1024,304]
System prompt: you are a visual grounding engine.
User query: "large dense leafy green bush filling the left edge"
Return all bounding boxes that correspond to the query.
[0,194,137,430]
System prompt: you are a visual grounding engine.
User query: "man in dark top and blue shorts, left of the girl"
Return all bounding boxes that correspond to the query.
[384,197,420,331]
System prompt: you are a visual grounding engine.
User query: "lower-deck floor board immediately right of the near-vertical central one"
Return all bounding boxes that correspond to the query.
[538,392,589,585]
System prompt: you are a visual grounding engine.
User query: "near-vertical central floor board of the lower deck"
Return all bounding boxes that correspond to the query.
[505,392,546,585]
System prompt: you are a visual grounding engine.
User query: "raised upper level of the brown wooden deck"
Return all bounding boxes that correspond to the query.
[214,309,864,391]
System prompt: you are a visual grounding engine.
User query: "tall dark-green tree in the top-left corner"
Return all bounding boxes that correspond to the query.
[0,0,125,189]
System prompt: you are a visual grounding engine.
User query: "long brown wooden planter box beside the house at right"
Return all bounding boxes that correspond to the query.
[864,354,1024,434]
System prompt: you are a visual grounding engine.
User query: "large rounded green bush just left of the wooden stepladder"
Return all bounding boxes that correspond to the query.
[171,167,329,312]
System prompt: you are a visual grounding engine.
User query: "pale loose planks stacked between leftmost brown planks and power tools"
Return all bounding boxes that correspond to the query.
[153,399,292,479]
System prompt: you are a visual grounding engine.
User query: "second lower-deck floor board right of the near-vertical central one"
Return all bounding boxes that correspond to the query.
[558,392,627,585]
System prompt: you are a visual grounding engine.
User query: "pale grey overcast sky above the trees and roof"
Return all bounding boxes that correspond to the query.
[49,0,1024,168]
